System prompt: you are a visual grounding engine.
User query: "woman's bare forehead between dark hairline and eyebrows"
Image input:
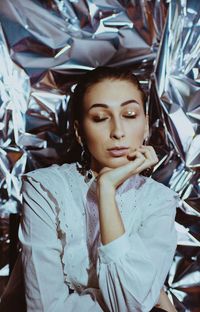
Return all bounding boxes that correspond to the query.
[84,79,143,108]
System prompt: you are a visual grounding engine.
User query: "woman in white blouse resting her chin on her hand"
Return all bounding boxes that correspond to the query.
[2,67,178,312]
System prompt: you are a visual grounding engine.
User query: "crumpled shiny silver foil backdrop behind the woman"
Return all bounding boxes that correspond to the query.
[0,0,200,312]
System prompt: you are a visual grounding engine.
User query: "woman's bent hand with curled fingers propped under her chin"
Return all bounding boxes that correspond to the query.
[97,145,158,189]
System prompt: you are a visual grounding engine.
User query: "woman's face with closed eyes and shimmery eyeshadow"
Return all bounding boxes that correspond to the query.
[78,79,148,173]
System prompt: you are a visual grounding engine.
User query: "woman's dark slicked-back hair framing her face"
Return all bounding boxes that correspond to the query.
[67,67,146,169]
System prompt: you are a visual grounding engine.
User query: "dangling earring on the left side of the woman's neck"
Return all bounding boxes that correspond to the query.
[76,142,93,183]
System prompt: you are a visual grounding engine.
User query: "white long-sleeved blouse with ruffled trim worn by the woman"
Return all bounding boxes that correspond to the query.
[19,164,179,312]
